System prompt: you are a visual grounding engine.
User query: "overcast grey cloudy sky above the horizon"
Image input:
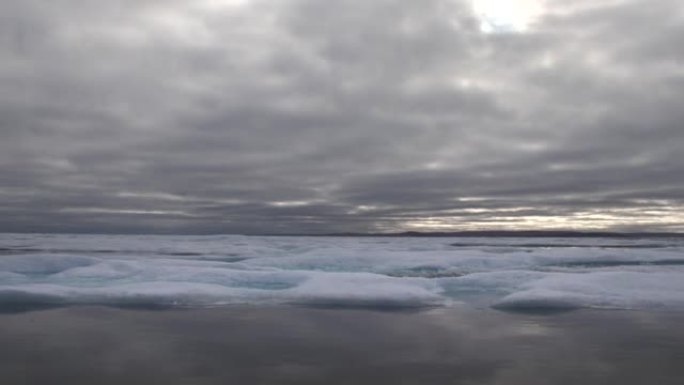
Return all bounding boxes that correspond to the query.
[0,0,684,234]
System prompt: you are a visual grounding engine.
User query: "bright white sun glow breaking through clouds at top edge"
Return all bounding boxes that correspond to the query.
[472,0,543,33]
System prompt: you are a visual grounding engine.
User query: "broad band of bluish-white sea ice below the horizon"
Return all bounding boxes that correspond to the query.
[0,234,684,311]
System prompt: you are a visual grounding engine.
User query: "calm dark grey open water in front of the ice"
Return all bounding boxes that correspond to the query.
[0,307,684,385]
